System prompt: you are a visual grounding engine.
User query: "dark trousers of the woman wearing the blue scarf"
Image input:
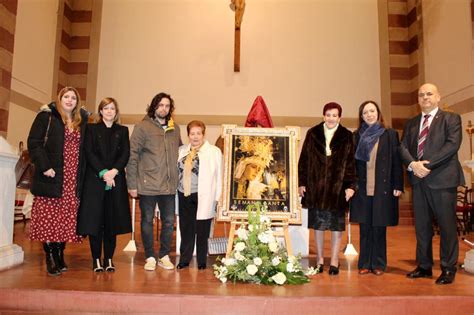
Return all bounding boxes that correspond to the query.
[358,197,387,270]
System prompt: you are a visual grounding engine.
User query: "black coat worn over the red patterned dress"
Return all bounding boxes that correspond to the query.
[28,102,87,198]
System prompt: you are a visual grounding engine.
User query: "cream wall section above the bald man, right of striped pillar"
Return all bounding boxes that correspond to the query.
[423,0,474,105]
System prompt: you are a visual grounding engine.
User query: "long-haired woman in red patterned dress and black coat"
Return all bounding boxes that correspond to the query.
[28,87,87,276]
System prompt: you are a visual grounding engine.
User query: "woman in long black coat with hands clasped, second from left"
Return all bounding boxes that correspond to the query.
[78,97,132,272]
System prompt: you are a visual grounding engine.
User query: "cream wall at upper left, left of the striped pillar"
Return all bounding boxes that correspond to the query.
[7,0,58,147]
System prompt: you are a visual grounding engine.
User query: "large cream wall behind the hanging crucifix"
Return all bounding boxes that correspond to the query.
[97,0,380,117]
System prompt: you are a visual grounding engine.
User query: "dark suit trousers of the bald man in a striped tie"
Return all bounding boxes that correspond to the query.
[413,181,459,272]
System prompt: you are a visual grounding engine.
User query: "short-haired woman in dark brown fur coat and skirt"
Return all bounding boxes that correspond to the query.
[298,103,356,275]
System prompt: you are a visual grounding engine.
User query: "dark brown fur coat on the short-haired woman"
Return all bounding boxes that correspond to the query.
[298,123,356,214]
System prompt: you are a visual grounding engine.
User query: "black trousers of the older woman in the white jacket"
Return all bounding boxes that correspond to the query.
[178,192,212,265]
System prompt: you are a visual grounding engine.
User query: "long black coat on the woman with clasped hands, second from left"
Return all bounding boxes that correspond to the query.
[77,122,132,235]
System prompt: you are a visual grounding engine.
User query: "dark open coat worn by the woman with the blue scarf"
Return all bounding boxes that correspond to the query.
[350,129,403,226]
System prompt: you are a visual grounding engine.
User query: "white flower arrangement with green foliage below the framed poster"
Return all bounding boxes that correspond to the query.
[213,202,311,285]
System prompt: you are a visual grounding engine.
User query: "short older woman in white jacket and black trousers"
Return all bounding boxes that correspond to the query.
[177,120,222,269]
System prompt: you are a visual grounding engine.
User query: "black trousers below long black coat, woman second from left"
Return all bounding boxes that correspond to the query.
[89,191,117,260]
